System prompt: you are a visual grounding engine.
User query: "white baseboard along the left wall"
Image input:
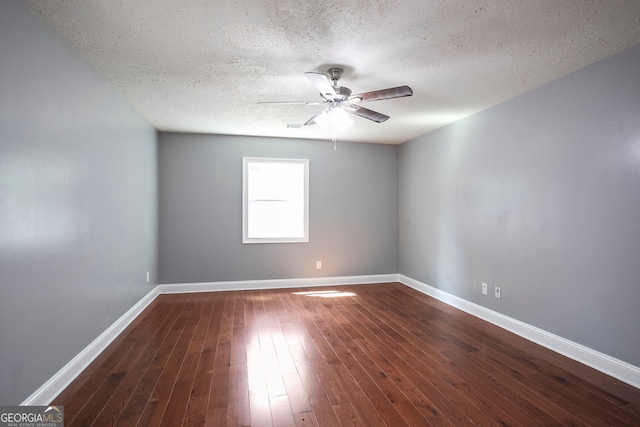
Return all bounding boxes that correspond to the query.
[20,287,158,406]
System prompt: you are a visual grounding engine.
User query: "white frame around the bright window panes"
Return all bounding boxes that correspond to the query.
[242,157,309,244]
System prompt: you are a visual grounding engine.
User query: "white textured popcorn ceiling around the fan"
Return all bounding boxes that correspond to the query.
[24,0,640,144]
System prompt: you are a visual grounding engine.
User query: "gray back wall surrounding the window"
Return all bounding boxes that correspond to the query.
[159,133,398,283]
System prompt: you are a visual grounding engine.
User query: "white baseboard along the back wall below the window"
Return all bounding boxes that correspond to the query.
[157,274,398,294]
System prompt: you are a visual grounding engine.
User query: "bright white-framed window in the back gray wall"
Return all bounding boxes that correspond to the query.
[242,157,309,243]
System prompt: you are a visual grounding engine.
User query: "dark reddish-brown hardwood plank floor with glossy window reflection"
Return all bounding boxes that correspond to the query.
[53,283,640,427]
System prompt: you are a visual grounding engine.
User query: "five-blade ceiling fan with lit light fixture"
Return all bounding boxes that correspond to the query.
[258,68,413,127]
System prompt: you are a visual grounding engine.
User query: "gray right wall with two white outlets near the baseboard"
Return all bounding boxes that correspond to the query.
[400,46,640,366]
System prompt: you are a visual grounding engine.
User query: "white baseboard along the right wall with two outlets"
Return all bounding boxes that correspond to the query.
[398,274,640,388]
